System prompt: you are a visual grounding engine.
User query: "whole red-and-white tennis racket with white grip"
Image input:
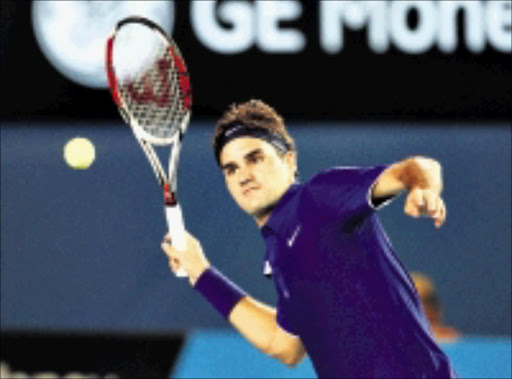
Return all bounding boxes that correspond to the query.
[106,16,192,277]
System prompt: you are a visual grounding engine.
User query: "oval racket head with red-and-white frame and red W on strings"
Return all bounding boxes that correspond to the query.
[106,16,192,145]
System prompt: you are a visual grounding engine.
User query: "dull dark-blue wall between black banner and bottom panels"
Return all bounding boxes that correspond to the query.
[0,122,511,335]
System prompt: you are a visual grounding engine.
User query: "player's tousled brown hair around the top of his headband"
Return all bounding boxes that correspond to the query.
[212,99,296,161]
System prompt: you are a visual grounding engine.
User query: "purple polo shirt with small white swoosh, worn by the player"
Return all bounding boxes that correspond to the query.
[262,166,451,378]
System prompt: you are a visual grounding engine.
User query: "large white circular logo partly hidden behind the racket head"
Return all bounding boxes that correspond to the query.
[32,0,174,88]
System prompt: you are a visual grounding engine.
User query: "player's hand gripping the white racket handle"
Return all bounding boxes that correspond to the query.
[161,231,210,286]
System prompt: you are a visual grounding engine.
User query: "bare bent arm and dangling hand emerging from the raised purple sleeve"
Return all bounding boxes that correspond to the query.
[372,156,446,228]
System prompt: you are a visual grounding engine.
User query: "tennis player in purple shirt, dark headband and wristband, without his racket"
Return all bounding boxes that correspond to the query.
[162,100,451,378]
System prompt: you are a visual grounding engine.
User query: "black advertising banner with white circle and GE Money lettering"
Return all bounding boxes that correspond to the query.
[1,0,512,121]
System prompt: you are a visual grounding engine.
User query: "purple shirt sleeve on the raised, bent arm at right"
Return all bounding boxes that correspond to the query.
[307,165,391,224]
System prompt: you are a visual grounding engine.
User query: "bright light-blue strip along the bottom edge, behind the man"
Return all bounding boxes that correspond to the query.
[170,330,512,379]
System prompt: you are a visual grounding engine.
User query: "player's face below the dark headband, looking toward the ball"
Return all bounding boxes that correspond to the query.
[220,137,297,225]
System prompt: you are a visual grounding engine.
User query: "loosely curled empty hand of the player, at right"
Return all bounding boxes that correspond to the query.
[404,188,446,228]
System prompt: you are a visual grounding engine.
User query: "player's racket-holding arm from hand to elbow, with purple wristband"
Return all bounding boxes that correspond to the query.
[161,233,306,366]
